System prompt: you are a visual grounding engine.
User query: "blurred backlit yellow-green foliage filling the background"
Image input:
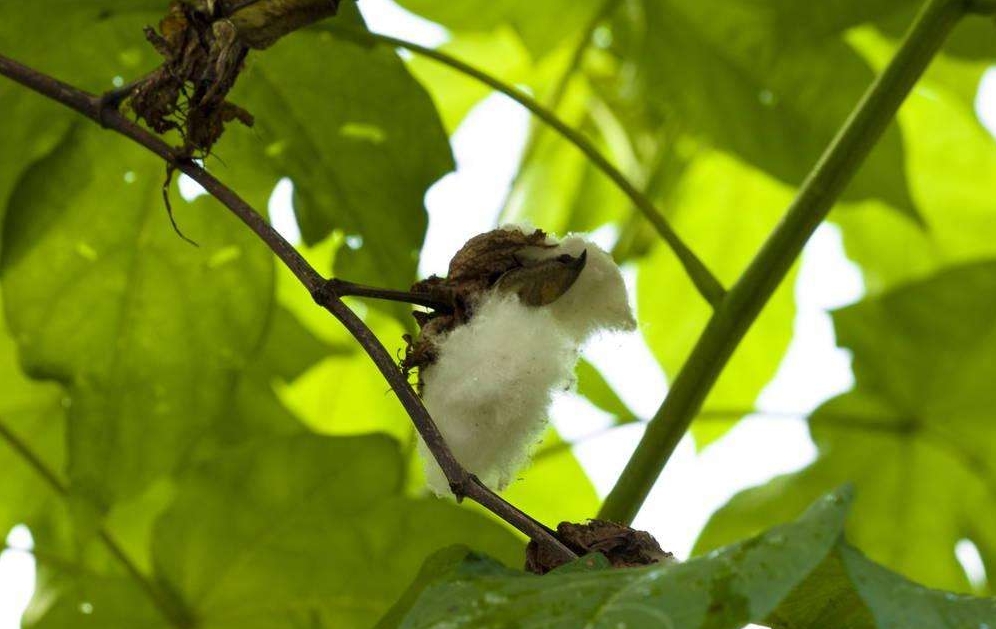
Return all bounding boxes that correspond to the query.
[0,0,996,627]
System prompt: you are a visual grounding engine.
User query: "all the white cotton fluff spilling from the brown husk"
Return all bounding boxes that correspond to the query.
[419,226,636,495]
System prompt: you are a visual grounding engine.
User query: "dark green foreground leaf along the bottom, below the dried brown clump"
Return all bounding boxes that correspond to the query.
[386,492,849,629]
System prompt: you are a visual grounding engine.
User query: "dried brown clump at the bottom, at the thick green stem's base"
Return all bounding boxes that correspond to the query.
[526,520,675,574]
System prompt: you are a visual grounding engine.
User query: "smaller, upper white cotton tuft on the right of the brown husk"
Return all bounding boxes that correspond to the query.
[524,235,636,343]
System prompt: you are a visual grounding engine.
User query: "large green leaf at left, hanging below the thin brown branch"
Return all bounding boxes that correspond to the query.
[0,123,272,506]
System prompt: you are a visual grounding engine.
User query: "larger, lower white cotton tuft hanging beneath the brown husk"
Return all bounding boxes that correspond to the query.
[419,293,577,495]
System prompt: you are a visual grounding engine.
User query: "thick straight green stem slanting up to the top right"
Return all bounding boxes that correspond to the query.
[598,0,968,522]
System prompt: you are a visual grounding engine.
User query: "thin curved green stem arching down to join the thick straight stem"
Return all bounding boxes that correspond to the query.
[328,25,726,308]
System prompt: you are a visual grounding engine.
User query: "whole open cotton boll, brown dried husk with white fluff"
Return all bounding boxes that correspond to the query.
[402,226,636,495]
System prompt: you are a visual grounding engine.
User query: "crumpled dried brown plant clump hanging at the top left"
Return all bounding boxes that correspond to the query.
[119,0,338,157]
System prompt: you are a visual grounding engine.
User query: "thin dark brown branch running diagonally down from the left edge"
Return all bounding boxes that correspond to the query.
[0,55,576,561]
